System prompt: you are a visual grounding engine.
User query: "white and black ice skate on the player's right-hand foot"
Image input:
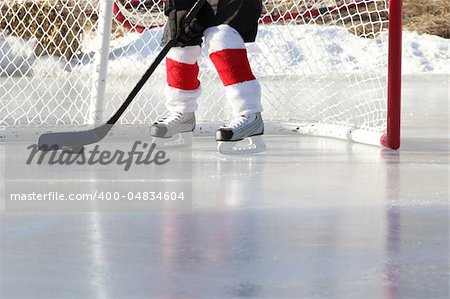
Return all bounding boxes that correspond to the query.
[216,113,266,155]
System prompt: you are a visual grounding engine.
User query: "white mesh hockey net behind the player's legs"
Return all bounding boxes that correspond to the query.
[0,0,400,148]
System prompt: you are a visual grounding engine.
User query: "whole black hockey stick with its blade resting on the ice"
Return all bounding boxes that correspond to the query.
[38,0,206,151]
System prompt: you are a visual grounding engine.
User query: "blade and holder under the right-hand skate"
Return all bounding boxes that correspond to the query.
[217,136,266,155]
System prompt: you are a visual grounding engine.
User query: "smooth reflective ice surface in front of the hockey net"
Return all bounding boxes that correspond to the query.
[0,76,449,299]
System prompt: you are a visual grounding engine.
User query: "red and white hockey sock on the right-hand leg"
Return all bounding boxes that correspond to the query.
[204,25,263,115]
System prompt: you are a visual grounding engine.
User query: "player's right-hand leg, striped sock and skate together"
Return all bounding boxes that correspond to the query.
[204,24,266,154]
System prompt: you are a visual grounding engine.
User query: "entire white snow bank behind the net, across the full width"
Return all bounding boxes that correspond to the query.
[0,25,450,76]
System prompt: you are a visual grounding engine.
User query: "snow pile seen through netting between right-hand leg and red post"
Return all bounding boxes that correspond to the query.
[249,25,386,76]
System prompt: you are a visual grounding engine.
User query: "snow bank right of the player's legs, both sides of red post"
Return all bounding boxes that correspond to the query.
[255,25,450,75]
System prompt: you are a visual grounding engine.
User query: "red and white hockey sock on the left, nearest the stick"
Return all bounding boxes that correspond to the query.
[165,46,202,112]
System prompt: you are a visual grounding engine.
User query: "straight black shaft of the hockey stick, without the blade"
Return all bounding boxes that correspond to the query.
[106,0,206,125]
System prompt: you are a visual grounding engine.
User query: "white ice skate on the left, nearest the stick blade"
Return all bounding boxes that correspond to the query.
[150,111,195,148]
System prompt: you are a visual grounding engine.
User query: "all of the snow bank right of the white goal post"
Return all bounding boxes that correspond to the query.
[100,25,450,76]
